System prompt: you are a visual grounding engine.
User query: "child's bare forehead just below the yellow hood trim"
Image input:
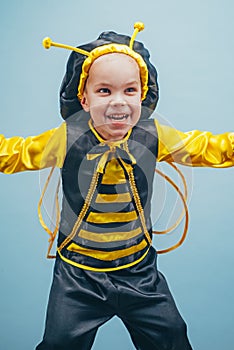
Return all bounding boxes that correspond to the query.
[89,53,140,78]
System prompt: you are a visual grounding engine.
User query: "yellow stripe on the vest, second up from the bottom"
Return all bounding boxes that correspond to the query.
[79,227,142,242]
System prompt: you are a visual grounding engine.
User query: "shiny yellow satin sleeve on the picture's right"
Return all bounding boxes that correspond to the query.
[155,121,234,168]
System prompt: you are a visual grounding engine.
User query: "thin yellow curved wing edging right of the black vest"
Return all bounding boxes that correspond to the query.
[153,163,189,254]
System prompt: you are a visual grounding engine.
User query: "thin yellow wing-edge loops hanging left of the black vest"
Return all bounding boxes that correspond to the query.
[38,167,60,259]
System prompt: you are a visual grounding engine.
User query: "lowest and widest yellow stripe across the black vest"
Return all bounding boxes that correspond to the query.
[67,240,147,261]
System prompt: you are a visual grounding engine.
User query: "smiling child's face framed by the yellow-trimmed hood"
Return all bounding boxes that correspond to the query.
[81,53,141,140]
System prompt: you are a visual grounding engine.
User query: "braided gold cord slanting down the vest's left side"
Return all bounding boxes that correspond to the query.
[58,172,99,251]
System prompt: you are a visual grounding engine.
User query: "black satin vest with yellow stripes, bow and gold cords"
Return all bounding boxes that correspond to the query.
[58,119,158,271]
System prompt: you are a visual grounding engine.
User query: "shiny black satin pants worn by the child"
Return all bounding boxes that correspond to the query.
[36,248,192,350]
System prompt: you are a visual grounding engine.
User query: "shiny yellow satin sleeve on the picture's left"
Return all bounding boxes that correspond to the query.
[0,123,66,174]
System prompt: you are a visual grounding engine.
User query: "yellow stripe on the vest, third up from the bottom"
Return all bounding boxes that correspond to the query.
[87,210,137,224]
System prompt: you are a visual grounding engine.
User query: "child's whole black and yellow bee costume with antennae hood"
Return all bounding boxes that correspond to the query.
[0,23,234,350]
